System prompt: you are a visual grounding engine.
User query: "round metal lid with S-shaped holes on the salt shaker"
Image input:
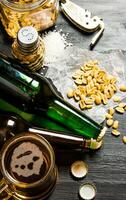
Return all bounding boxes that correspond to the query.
[17,26,39,48]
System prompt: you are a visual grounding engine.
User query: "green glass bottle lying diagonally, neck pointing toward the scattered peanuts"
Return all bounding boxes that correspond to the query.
[0,55,102,139]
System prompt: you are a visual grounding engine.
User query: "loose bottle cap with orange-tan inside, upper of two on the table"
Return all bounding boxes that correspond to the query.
[71,160,88,178]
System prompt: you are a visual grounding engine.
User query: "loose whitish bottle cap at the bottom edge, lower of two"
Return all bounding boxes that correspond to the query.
[79,182,96,200]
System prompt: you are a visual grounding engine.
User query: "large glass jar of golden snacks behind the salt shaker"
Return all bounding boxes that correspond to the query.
[0,0,59,38]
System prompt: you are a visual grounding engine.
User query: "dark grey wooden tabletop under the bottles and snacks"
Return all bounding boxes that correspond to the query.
[0,0,126,200]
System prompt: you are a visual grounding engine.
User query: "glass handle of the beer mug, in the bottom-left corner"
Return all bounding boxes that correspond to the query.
[0,178,12,200]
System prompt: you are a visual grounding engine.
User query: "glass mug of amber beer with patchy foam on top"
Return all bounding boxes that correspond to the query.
[0,133,57,200]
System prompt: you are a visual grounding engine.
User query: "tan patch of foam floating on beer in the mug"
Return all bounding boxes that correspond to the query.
[10,142,44,177]
